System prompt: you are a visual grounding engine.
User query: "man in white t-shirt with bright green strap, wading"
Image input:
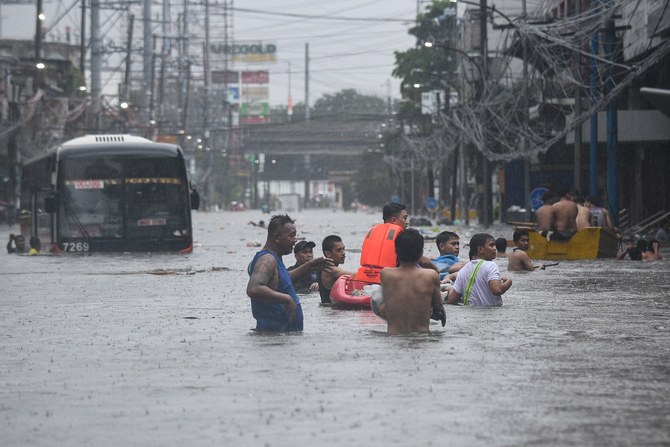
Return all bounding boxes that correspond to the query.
[447,233,512,306]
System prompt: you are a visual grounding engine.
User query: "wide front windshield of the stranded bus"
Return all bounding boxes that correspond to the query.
[58,157,190,240]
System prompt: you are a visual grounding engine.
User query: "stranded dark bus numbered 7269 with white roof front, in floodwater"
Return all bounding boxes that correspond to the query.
[20,135,199,253]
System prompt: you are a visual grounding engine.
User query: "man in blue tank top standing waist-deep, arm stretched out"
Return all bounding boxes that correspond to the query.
[247,214,333,331]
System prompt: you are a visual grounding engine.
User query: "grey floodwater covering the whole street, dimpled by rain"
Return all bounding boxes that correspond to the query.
[0,210,670,446]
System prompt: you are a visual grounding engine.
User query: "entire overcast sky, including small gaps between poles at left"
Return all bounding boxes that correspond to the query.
[0,0,425,105]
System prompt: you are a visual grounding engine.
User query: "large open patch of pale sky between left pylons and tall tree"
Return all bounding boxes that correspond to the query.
[234,0,416,104]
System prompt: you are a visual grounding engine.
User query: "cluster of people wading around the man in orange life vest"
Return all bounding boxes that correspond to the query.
[247,203,512,334]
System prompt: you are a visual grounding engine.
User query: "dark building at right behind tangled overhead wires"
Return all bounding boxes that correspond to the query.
[462,0,670,229]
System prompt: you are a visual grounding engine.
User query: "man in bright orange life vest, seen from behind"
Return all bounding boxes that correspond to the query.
[356,202,437,284]
